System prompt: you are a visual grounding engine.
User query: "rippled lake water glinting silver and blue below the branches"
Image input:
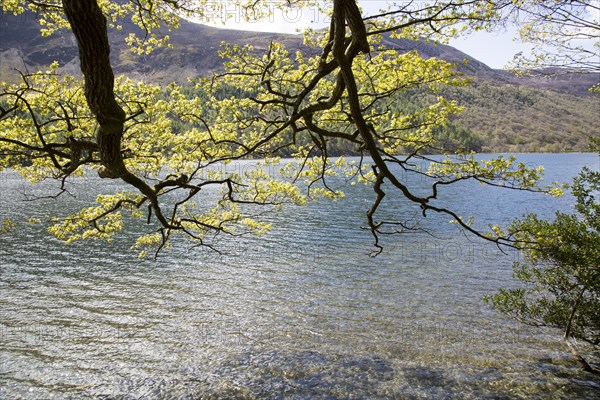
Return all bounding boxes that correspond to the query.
[0,154,600,399]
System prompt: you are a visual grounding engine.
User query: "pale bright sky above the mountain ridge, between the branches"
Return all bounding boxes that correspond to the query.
[193,0,540,68]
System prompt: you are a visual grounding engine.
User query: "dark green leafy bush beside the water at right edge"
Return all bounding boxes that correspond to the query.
[486,141,600,375]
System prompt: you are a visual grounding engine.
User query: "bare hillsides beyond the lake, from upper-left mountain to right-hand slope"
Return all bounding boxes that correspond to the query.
[0,14,600,151]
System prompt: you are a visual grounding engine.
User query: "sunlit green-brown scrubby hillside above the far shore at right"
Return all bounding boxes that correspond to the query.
[444,82,600,152]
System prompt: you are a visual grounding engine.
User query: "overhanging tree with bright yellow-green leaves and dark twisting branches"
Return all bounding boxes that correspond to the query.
[0,0,572,252]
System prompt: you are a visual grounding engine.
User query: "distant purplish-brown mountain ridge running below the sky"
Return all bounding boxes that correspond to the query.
[0,12,598,95]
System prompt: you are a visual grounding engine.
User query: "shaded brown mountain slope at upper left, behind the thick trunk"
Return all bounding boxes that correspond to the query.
[0,13,302,83]
